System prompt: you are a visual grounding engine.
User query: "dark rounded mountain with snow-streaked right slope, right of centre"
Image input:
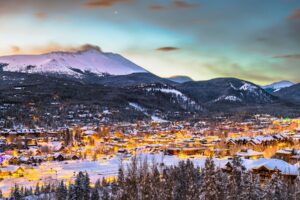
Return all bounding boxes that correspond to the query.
[178,78,276,106]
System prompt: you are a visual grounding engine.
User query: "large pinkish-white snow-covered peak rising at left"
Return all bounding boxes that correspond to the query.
[0,48,147,77]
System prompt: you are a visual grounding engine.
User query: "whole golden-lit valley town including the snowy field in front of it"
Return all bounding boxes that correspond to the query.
[0,115,300,197]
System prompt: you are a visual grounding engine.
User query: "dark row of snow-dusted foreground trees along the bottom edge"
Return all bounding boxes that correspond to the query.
[11,158,300,200]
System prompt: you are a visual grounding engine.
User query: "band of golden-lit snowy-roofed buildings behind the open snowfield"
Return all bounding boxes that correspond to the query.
[0,113,300,182]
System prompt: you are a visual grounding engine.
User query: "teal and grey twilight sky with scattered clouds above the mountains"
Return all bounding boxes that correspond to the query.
[0,0,300,85]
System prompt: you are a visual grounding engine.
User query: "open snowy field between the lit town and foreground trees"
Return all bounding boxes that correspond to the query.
[0,154,226,194]
